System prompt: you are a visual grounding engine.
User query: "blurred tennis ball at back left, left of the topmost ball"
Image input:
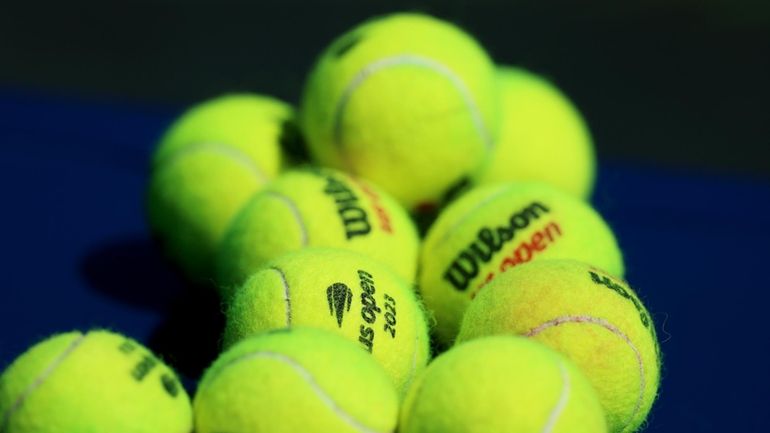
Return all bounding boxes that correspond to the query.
[147,95,292,283]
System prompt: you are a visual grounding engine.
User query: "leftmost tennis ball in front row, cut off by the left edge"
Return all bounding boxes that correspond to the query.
[0,331,193,433]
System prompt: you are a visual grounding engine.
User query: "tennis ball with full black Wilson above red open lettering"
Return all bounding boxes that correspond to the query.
[418,182,623,344]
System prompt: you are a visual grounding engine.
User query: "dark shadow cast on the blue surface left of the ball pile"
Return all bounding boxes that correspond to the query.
[81,238,224,378]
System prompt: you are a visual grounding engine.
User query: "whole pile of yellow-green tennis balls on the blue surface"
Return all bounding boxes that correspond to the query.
[0,14,661,433]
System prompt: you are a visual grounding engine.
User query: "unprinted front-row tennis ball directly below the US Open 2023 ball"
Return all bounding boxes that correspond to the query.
[194,328,398,433]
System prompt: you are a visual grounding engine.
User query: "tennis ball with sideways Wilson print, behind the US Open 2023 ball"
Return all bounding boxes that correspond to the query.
[218,169,419,299]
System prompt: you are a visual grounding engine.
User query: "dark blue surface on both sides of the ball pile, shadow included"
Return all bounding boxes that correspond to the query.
[0,91,770,432]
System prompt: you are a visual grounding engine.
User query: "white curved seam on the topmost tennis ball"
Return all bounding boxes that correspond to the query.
[333,54,494,151]
